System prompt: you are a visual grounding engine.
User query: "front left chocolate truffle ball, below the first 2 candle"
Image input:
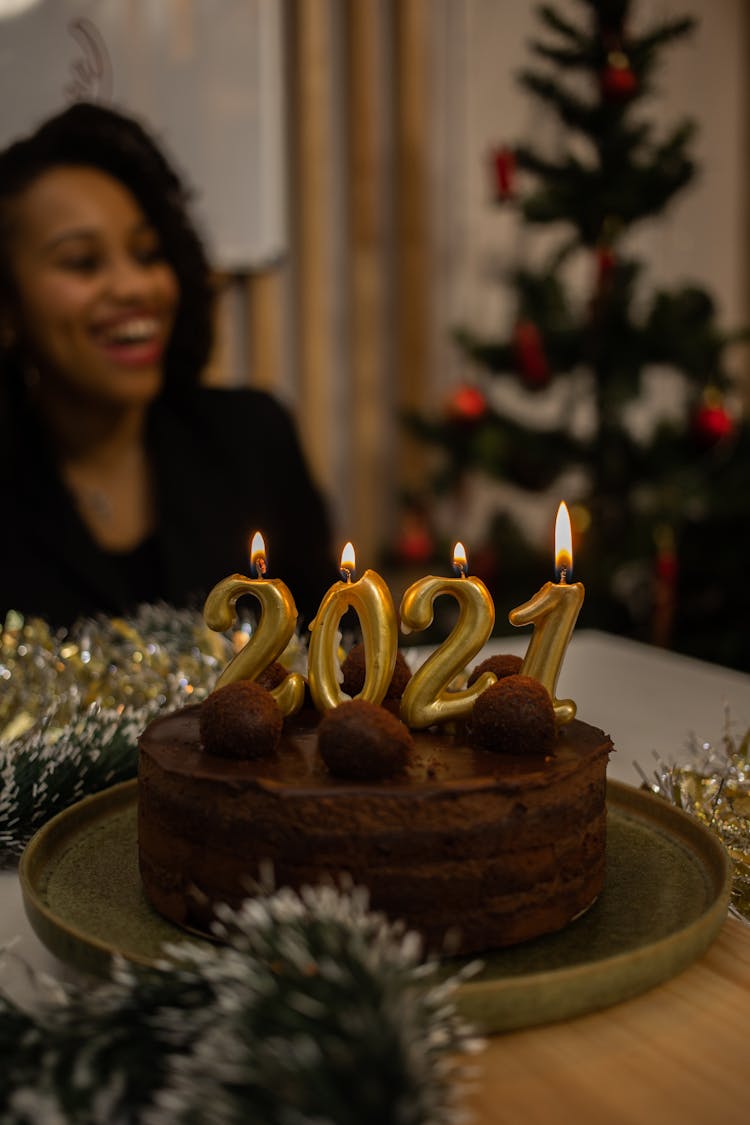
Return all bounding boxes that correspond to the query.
[199,680,283,759]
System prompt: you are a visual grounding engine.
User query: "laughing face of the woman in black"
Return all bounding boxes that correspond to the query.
[9,168,179,407]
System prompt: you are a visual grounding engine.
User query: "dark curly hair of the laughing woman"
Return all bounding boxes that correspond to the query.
[0,102,213,395]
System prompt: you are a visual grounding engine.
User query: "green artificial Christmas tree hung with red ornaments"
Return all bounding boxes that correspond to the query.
[408,0,750,668]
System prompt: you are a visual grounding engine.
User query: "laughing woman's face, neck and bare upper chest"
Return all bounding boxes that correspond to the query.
[8,167,179,551]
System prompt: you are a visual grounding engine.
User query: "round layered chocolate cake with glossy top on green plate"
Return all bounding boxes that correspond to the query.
[138,677,612,954]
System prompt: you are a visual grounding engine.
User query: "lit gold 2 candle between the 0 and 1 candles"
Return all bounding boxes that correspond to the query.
[400,543,496,729]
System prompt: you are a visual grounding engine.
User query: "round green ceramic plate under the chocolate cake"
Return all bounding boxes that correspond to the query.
[19,781,732,1032]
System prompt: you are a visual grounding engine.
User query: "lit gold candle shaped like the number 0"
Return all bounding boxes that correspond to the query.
[307,543,398,711]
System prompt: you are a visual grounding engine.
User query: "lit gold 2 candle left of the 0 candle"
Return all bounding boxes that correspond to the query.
[204,531,305,714]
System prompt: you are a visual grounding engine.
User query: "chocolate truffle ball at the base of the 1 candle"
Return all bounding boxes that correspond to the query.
[469,675,555,754]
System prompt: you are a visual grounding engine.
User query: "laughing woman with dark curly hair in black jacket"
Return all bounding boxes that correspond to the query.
[0,104,333,624]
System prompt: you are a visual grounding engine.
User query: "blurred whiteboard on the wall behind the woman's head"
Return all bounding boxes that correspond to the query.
[0,0,286,271]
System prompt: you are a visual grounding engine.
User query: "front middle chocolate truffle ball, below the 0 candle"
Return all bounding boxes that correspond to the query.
[318,700,414,781]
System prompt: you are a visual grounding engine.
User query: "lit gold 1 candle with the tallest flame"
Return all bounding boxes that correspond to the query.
[508,503,585,727]
